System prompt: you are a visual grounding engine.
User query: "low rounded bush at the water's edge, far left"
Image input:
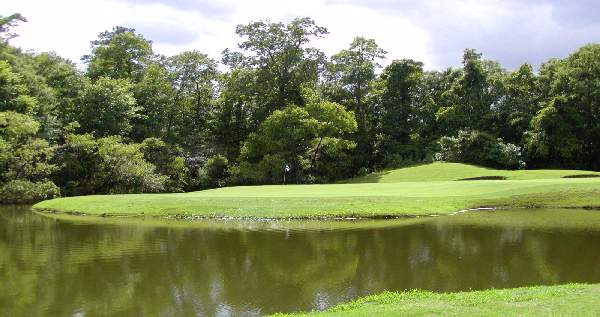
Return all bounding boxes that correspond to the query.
[0,180,60,204]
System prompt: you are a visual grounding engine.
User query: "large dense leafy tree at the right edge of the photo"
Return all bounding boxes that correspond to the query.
[526,44,600,170]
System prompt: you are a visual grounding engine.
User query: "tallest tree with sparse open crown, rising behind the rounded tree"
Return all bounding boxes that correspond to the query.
[231,18,328,121]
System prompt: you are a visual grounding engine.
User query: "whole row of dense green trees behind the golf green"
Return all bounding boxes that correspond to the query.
[0,14,600,203]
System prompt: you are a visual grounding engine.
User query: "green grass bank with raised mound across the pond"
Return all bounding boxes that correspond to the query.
[34,163,600,218]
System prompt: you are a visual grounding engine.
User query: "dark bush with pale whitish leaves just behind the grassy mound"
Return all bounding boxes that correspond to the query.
[435,131,525,169]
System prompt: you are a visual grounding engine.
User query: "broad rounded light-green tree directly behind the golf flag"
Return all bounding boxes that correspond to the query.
[240,100,356,183]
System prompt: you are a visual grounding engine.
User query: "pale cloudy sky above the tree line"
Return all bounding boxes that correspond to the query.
[0,0,600,69]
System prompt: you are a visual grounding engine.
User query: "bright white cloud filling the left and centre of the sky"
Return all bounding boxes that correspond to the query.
[4,0,431,66]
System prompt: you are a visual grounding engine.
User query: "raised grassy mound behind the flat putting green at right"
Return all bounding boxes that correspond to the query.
[345,162,600,183]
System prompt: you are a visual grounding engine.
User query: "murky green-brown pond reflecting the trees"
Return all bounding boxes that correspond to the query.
[0,207,600,316]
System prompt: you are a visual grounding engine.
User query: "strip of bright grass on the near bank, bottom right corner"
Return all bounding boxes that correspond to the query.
[278,284,600,317]
